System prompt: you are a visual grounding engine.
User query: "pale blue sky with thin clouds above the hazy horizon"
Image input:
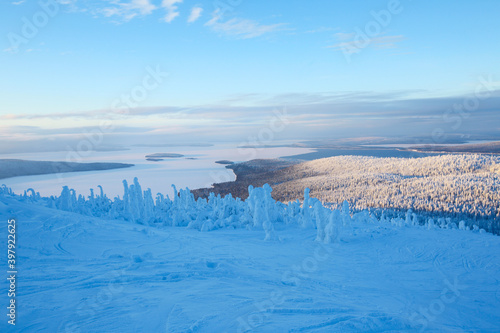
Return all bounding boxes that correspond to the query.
[0,0,500,153]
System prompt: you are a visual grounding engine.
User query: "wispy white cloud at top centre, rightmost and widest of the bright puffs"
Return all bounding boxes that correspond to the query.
[205,10,284,39]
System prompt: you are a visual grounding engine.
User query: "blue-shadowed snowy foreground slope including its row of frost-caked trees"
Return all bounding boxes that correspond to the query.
[0,183,500,332]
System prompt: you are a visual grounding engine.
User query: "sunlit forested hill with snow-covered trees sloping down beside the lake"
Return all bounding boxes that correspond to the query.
[195,155,500,234]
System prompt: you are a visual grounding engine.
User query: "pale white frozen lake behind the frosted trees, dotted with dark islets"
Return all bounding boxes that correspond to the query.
[0,144,312,196]
